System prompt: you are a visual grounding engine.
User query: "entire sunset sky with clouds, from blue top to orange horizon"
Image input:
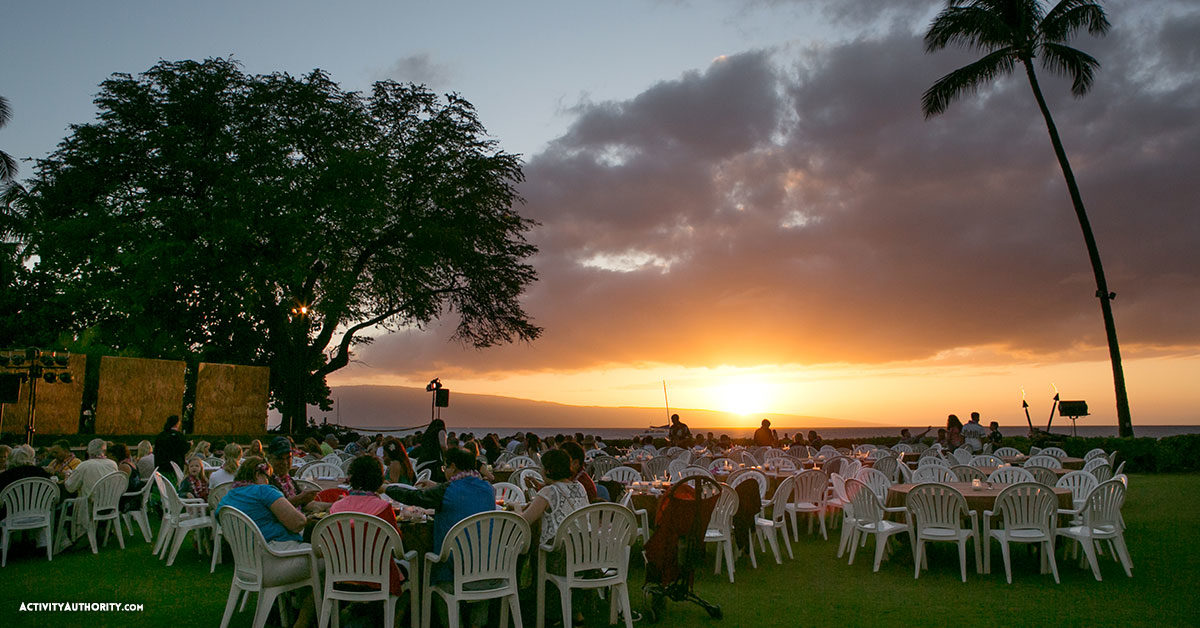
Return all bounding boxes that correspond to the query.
[0,0,1200,429]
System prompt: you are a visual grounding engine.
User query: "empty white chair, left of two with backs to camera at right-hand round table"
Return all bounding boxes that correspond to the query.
[906,484,983,582]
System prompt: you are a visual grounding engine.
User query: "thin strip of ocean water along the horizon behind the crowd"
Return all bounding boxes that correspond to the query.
[343,424,1200,441]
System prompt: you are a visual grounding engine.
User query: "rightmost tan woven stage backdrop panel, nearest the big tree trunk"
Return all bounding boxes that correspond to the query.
[192,363,271,435]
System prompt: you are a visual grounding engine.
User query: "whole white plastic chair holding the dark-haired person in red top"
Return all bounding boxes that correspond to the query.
[312,513,420,628]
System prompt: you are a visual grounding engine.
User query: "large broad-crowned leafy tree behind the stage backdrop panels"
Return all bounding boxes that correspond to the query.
[14,59,541,427]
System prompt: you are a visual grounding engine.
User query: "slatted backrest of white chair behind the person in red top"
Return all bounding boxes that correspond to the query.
[312,513,404,596]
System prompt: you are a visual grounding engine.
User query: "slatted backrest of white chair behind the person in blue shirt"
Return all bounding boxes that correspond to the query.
[440,506,530,596]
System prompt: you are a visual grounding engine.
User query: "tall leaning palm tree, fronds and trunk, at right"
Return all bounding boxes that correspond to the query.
[920,0,1133,437]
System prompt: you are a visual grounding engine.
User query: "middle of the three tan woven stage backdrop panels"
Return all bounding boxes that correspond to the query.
[96,355,185,435]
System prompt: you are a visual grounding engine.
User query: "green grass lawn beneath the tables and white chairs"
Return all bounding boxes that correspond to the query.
[0,474,1200,628]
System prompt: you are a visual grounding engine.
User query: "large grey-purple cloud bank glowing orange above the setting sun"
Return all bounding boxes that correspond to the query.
[352,2,1200,375]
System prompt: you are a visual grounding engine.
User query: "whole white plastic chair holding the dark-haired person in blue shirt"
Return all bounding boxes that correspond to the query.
[421,510,530,628]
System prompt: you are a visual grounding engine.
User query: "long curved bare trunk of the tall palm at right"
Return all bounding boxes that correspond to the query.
[1022,58,1133,438]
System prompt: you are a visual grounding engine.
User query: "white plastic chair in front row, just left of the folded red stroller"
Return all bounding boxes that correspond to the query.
[538,503,637,628]
